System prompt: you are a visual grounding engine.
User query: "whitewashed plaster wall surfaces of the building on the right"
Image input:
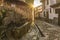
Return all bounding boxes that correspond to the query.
[40,0,58,20]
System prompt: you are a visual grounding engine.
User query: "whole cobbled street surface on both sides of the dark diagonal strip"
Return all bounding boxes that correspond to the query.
[10,20,60,40]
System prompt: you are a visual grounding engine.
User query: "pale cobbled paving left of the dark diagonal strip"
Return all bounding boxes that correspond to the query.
[20,27,40,40]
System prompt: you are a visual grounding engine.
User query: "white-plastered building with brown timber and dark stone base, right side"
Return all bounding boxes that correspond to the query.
[41,0,58,24]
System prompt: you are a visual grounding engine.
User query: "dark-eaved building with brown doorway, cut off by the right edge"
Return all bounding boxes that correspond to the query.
[50,0,60,25]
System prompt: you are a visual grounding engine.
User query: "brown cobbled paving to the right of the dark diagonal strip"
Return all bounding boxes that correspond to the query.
[35,20,60,40]
